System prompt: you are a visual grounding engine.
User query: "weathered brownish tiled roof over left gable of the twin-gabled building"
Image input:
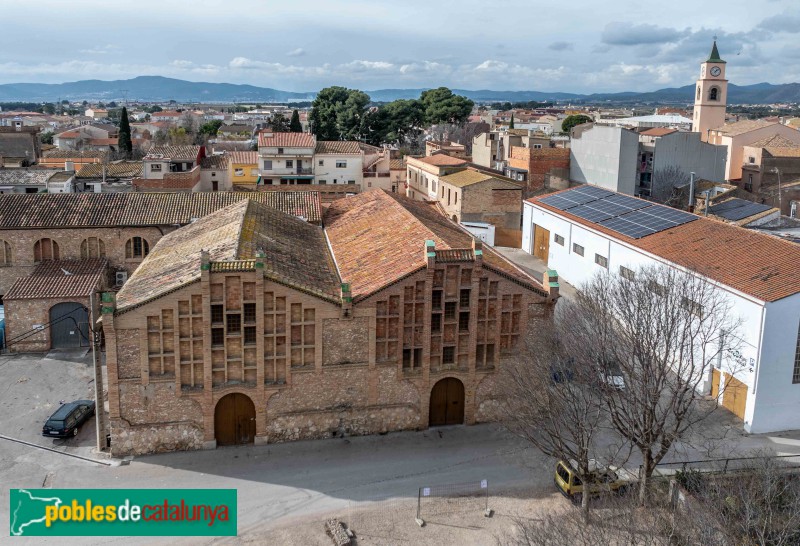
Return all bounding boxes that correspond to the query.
[117,199,340,311]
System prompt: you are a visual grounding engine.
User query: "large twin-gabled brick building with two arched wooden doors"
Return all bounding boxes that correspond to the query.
[102,191,557,454]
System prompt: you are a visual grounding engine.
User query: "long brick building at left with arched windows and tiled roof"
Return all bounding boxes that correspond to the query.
[0,192,321,352]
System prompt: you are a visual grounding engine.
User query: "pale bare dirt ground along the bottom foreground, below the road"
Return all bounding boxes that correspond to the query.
[235,484,570,546]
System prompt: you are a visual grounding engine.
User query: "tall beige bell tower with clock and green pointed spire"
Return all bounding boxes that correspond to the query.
[692,36,728,142]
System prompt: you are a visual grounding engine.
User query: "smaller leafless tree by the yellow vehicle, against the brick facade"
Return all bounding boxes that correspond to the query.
[498,302,620,521]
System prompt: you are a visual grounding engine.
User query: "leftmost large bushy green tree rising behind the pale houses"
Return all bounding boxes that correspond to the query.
[309,86,370,140]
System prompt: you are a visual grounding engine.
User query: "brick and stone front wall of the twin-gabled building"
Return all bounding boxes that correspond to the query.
[104,253,550,455]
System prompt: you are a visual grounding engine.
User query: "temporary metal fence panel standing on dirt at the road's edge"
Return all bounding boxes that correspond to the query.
[416,480,491,526]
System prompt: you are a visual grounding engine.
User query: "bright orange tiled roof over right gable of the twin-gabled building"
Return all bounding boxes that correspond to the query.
[324,190,542,299]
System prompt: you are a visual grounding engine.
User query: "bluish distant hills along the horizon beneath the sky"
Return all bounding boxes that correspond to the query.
[0,76,800,104]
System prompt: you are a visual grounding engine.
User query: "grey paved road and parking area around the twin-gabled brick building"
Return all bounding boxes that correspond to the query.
[0,350,800,545]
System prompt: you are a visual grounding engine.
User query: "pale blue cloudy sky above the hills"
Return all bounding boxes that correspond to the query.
[0,0,800,93]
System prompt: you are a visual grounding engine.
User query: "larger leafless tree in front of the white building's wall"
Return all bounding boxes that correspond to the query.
[576,266,741,504]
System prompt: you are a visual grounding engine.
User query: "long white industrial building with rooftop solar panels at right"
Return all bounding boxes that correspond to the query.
[522,185,800,433]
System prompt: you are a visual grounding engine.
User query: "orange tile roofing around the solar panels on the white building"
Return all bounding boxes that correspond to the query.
[528,188,800,301]
